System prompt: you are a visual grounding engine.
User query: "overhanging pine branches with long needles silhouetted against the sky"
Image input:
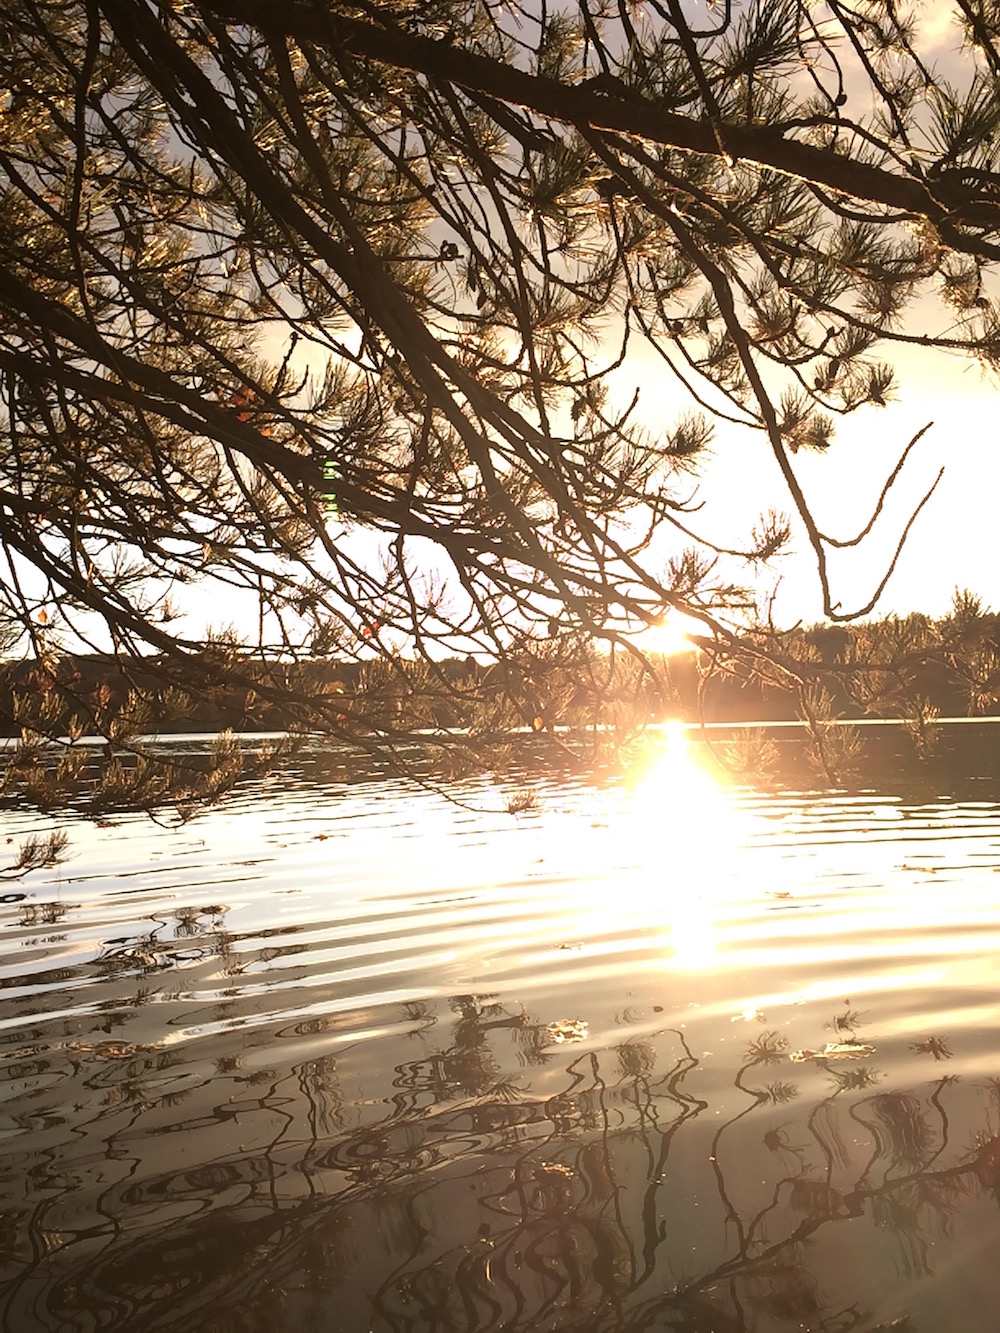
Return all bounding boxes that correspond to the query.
[0,0,1000,802]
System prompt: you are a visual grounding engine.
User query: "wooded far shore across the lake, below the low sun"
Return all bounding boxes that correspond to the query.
[0,593,1000,745]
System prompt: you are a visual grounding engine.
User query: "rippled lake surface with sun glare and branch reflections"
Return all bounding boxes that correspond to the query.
[0,728,1000,1333]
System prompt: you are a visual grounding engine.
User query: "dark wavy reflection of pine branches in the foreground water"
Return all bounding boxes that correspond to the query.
[0,986,1000,1333]
